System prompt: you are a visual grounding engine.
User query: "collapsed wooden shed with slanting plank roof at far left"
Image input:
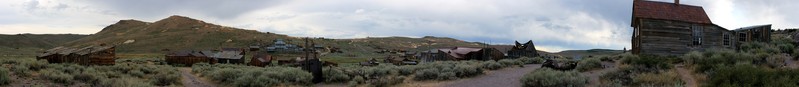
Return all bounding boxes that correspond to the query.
[36,44,116,65]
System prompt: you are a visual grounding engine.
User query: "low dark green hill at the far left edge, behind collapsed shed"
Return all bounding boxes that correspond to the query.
[0,34,89,55]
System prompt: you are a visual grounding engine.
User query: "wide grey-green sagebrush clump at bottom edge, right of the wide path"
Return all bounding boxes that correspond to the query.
[520,68,588,87]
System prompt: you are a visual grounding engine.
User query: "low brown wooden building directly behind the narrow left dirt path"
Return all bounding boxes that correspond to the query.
[164,50,216,65]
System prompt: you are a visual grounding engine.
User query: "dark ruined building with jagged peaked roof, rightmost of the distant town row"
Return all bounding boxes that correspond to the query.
[507,40,538,58]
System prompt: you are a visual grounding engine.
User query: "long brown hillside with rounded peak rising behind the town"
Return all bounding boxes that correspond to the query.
[65,15,484,59]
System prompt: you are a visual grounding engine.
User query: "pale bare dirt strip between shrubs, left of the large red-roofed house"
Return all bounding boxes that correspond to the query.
[581,62,618,87]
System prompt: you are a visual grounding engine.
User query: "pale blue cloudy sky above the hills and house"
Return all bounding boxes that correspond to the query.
[0,0,799,52]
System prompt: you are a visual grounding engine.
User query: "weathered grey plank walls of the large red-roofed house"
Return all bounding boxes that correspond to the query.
[632,19,735,55]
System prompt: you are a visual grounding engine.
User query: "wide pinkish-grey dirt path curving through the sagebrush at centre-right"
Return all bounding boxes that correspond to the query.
[442,64,541,87]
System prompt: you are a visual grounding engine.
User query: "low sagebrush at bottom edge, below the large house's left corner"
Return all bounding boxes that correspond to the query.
[632,70,683,86]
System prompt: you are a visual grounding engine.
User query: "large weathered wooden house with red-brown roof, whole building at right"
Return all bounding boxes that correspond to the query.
[631,0,736,55]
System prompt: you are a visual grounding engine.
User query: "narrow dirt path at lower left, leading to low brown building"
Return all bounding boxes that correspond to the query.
[179,67,216,87]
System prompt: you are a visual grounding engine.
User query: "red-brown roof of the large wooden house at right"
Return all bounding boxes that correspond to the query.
[631,0,712,26]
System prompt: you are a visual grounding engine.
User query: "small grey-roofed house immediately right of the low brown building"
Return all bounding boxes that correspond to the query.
[211,48,245,64]
